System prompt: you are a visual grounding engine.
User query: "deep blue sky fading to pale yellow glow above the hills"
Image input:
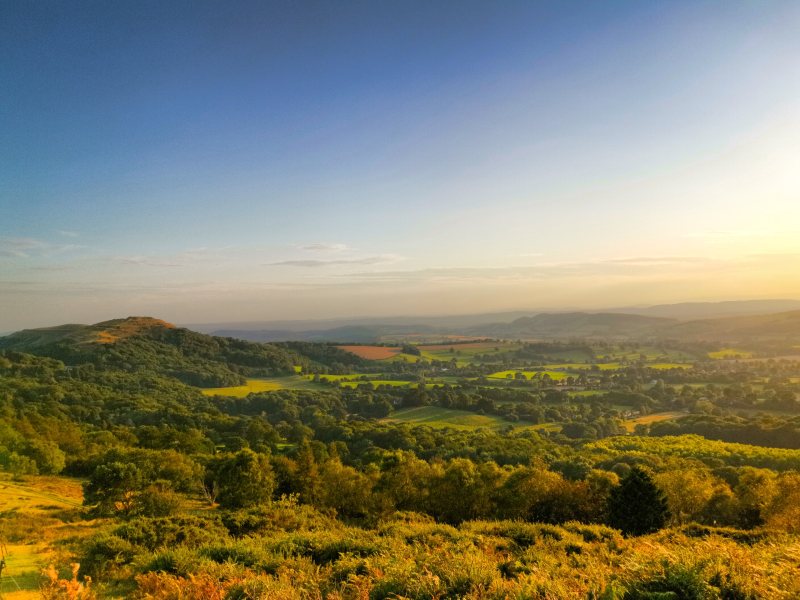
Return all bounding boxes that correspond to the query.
[0,0,800,331]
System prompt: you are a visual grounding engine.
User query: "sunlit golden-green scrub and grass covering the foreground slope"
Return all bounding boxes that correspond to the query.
[0,477,800,600]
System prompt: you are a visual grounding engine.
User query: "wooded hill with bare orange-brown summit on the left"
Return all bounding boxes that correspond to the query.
[0,317,358,386]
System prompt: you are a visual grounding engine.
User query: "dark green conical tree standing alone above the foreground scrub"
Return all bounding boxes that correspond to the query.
[608,467,670,535]
